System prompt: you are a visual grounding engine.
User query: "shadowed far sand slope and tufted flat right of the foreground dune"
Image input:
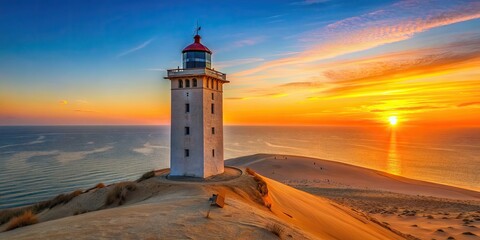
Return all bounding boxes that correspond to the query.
[226,154,480,239]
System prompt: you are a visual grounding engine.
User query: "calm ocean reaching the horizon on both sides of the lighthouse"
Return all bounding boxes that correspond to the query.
[0,126,480,208]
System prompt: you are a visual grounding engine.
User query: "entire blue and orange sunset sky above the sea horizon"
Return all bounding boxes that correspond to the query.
[0,0,480,127]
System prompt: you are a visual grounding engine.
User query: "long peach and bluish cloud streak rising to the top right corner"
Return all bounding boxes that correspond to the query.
[235,2,480,77]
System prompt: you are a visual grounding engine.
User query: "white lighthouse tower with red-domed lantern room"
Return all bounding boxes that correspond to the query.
[166,31,229,178]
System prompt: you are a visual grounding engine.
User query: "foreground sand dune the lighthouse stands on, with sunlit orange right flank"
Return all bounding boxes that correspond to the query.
[0,168,403,239]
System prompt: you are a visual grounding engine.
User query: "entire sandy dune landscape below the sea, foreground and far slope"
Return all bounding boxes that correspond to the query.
[0,154,480,239]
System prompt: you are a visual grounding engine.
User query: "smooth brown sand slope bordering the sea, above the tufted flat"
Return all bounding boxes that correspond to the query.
[225,153,480,202]
